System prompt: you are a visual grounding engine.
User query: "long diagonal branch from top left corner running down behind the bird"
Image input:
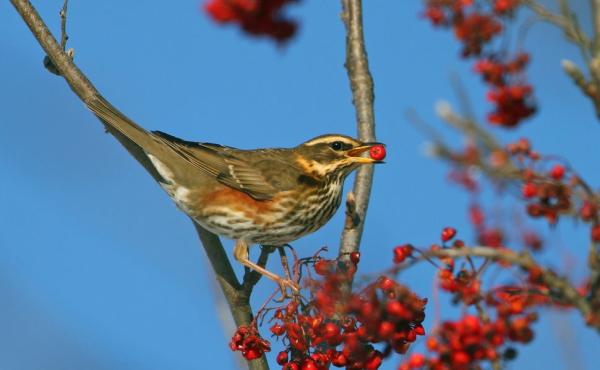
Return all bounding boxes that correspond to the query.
[11,0,269,370]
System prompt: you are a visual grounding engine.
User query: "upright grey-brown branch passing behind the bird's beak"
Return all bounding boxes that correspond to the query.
[339,0,375,256]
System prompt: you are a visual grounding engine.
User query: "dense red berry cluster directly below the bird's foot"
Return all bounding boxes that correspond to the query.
[231,253,427,370]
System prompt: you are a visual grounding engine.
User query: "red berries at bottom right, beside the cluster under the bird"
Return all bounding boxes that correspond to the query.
[394,227,564,370]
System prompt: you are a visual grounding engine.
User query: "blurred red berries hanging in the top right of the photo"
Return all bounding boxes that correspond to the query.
[425,0,536,127]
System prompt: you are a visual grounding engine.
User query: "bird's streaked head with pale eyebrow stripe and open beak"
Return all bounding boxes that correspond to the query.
[295,134,383,178]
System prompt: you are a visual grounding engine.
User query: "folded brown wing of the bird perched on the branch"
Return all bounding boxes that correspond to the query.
[153,131,298,200]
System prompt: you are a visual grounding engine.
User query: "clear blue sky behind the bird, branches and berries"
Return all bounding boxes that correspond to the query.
[0,0,600,370]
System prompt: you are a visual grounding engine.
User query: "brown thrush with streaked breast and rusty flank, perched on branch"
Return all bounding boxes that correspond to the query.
[85,95,383,292]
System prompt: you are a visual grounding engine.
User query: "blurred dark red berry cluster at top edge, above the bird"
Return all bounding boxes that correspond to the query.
[204,0,297,42]
